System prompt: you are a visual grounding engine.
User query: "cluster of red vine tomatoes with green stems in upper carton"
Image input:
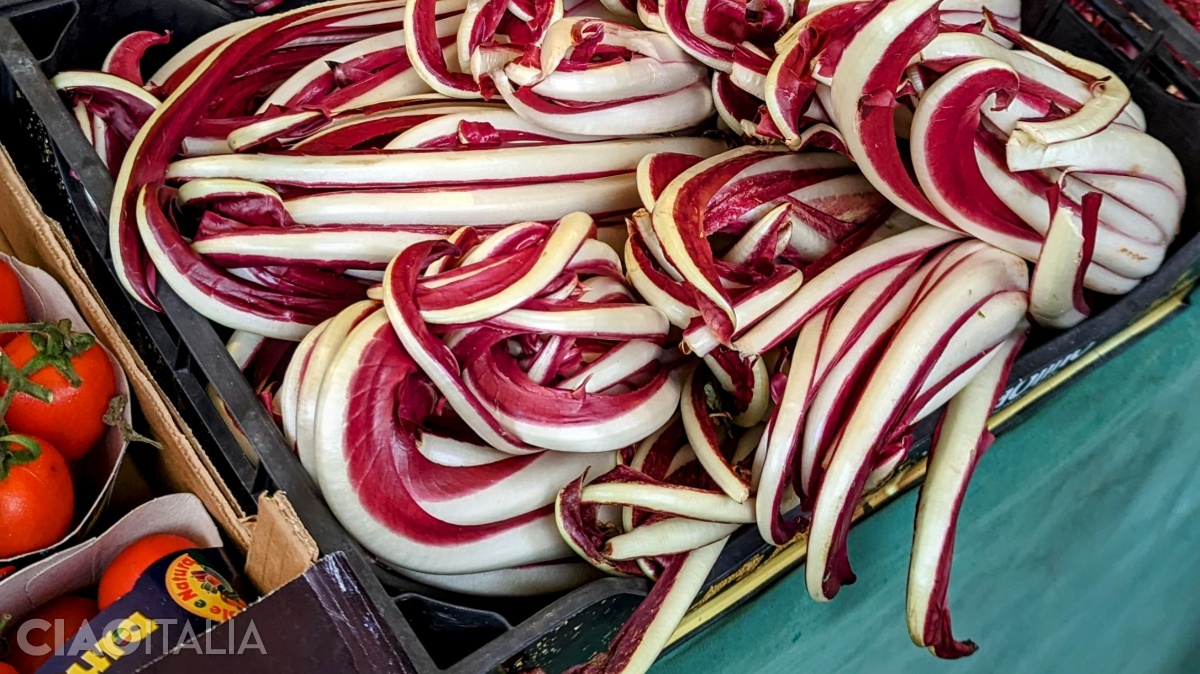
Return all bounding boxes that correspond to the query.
[0,261,118,559]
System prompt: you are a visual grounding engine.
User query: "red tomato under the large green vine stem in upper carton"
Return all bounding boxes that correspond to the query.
[0,333,116,463]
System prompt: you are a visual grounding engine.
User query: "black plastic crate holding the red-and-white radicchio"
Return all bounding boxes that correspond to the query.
[0,0,1200,674]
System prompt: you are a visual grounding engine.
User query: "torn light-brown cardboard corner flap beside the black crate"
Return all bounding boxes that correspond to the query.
[246,493,320,594]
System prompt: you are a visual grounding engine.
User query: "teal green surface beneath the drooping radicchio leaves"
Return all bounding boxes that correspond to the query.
[652,287,1200,674]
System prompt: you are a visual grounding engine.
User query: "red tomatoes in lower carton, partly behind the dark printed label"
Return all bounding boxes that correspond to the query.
[0,534,200,674]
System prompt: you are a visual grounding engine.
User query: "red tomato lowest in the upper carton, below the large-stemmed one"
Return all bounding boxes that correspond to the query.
[0,438,74,559]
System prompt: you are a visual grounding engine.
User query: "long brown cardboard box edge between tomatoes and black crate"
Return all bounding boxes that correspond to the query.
[0,149,251,552]
